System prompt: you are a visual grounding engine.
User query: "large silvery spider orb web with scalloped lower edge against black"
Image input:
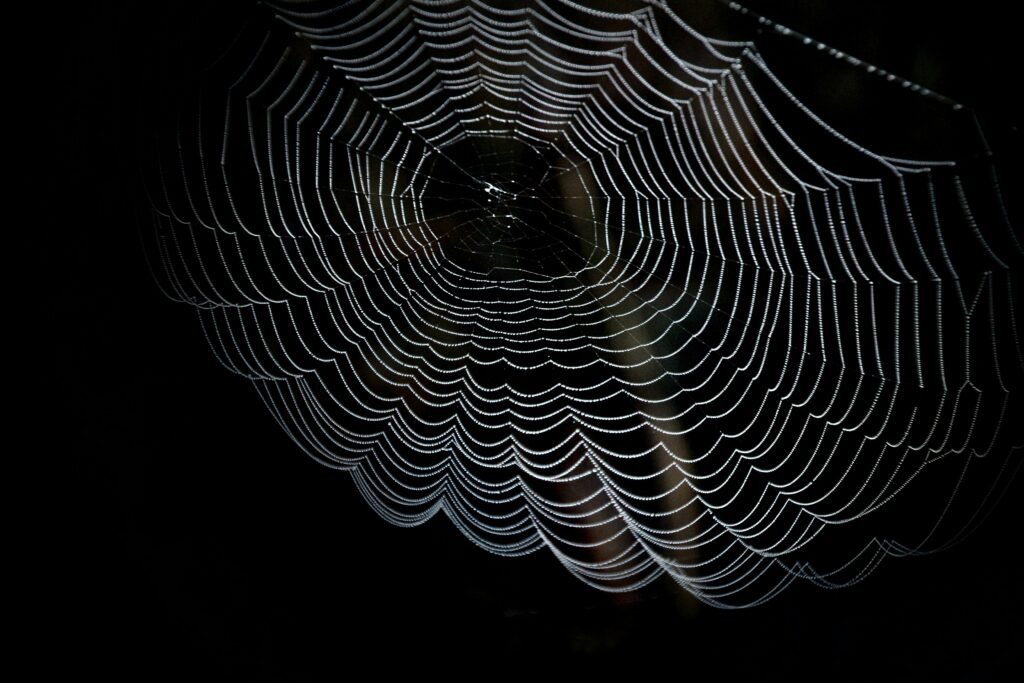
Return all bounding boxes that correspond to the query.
[151,0,1024,605]
